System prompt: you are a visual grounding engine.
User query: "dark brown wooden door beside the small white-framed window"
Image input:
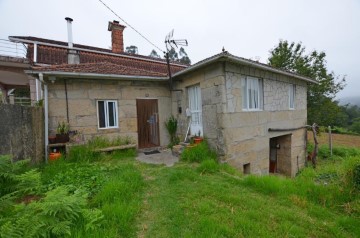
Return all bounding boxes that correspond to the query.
[136,99,160,148]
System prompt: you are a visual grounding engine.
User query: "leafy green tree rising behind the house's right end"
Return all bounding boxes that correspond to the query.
[268,40,345,126]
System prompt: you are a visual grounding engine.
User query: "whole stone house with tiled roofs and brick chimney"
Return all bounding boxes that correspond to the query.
[16,18,316,176]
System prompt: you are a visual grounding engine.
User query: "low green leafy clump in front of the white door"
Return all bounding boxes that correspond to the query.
[181,140,217,163]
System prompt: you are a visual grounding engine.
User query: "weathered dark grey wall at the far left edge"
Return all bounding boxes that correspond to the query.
[0,104,44,163]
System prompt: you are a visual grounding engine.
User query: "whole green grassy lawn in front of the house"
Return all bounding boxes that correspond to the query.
[0,142,360,237]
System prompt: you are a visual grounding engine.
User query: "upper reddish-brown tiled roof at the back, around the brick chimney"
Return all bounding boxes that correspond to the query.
[9,36,187,73]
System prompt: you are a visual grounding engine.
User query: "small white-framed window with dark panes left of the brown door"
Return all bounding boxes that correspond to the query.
[97,100,118,129]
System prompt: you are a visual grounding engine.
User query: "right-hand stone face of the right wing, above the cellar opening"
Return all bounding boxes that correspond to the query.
[221,63,307,176]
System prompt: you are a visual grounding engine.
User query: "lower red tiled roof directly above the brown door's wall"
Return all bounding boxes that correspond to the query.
[32,62,167,77]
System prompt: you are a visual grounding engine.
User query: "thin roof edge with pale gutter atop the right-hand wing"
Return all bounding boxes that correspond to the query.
[173,51,318,84]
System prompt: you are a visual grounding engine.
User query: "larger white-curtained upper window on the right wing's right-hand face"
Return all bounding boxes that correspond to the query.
[241,76,264,111]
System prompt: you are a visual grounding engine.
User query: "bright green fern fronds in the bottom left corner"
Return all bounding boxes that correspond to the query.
[0,186,103,237]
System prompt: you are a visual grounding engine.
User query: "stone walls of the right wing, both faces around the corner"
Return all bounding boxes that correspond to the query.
[172,62,307,176]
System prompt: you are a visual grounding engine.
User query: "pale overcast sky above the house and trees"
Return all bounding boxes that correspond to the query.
[0,0,360,98]
